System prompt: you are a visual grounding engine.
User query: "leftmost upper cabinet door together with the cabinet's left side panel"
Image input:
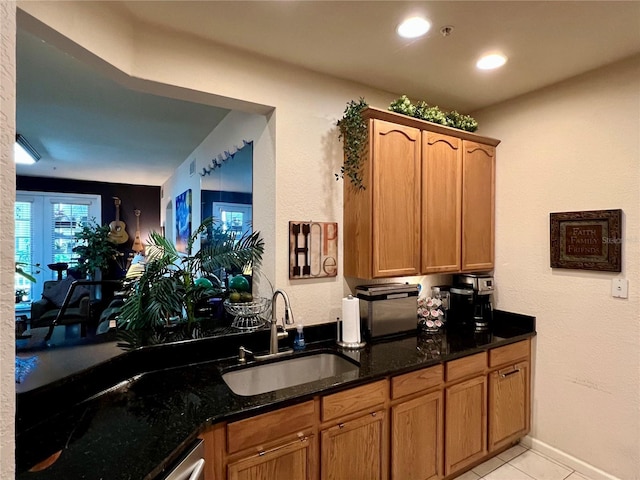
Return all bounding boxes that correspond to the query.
[343,119,421,278]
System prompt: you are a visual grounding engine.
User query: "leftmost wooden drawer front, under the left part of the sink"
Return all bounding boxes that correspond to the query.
[227,400,316,453]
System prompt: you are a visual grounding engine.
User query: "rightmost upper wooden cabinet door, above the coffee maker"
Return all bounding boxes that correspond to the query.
[462,140,496,271]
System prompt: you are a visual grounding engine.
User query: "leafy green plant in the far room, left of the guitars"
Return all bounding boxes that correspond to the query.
[73,220,118,276]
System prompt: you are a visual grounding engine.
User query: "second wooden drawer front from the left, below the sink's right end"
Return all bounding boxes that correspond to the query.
[322,380,389,422]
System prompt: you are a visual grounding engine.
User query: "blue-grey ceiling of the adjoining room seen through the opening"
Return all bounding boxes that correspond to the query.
[16,30,228,185]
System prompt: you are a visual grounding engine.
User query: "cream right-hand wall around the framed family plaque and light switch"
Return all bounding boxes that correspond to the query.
[475,57,640,480]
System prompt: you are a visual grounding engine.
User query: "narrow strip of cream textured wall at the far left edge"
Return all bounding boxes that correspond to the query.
[0,2,16,478]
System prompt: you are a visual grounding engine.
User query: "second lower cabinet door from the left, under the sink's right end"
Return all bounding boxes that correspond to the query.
[320,411,389,480]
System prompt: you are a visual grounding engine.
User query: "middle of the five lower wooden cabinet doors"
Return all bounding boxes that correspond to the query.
[391,391,444,480]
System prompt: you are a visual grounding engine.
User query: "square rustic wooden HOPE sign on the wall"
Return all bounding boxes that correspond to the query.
[289,222,338,279]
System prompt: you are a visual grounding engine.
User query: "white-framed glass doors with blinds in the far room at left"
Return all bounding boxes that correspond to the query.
[15,192,101,300]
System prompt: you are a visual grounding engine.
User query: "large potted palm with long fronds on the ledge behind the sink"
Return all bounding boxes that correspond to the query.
[118,217,264,330]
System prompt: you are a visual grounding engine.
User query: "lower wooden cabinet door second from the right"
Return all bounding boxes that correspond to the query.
[444,375,487,475]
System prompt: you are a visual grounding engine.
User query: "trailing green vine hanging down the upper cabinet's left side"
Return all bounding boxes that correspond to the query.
[335,97,369,190]
